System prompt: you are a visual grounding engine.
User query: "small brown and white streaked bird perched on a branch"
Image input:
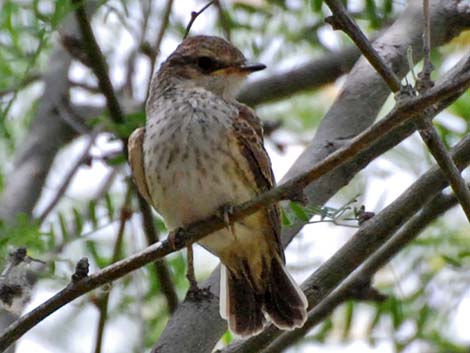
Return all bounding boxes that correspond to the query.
[128,35,307,337]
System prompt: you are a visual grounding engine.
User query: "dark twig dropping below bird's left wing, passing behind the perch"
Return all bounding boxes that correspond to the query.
[137,194,178,313]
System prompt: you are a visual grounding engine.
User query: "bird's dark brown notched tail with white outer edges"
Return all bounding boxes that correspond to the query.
[220,257,307,336]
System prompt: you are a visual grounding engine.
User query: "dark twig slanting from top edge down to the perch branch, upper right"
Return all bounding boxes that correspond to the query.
[325,0,401,92]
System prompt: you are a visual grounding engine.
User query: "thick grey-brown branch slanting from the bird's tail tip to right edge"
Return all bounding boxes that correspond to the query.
[220,136,470,353]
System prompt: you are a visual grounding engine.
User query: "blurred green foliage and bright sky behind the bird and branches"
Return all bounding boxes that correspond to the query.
[0,0,470,353]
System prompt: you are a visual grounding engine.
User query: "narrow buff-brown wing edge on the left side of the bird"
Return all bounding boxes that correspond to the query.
[127,127,152,204]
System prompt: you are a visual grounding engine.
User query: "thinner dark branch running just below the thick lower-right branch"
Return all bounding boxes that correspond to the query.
[263,186,458,353]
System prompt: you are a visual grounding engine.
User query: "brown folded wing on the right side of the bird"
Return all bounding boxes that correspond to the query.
[233,104,284,259]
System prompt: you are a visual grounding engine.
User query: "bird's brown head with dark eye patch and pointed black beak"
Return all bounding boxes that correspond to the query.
[157,36,266,98]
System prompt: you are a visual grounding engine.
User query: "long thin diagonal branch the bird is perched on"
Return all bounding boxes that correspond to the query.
[0,73,470,351]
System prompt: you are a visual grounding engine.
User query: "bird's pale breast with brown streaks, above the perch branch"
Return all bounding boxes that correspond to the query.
[143,95,254,229]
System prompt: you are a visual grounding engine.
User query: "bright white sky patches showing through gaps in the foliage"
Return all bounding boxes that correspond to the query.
[7,0,470,353]
